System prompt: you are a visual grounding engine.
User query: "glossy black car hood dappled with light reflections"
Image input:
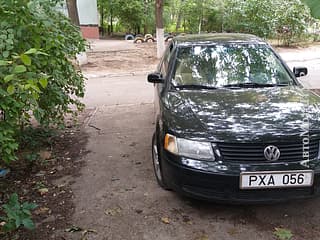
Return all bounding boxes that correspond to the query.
[164,87,320,141]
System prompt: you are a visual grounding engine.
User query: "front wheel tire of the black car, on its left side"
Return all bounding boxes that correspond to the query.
[152,133,171,190]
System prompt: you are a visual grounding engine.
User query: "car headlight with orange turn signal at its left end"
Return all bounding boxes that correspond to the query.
[164,134,215,160]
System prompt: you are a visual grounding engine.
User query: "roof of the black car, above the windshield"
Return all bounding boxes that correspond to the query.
[173,33,267,46]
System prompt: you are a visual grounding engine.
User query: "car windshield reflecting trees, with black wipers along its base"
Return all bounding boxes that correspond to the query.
[172,44,296,89]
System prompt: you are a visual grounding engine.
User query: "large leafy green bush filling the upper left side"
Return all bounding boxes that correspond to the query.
[0,0,85,163]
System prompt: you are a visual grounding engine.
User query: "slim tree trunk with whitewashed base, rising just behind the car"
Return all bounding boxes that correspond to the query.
[155,0,165,58]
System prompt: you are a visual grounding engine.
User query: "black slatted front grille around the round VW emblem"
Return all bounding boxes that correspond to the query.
[218,140,319,162]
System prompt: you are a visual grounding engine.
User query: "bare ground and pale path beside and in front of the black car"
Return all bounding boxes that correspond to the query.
[0,41,320,240]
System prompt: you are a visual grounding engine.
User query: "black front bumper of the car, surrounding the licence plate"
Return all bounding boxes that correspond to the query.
[162,151,320,203]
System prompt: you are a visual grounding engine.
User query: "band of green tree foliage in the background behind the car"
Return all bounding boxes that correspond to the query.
[98,0,320,41]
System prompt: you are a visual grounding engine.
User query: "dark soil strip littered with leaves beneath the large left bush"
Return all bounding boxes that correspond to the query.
[0,113,90,240]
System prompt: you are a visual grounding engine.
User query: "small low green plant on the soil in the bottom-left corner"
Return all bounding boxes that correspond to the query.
[0,193,37,232]
